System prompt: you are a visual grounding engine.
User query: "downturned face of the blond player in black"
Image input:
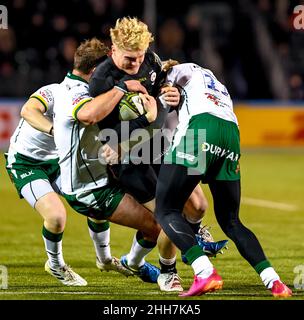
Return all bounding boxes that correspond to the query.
[112,46,146,74]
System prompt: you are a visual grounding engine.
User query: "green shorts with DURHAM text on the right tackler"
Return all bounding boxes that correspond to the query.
[164,113,240,183]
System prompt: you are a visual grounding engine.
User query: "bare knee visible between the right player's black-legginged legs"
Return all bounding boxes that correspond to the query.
[184,184,208,221]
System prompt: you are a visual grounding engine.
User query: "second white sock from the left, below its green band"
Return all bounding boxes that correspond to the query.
[89,228,112,263]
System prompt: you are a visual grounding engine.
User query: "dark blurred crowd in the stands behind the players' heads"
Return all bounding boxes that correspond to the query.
[0,0,304,100]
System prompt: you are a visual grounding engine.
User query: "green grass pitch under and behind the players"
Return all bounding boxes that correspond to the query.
[0,150,304,300]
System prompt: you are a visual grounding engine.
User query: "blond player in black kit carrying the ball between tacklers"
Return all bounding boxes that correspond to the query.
[89,17,226,291]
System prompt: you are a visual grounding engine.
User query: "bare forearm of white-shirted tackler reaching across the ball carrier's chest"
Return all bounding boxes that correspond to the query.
[77,88,124,125]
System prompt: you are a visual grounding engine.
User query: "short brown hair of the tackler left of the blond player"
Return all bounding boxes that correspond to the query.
[74,38,109,74]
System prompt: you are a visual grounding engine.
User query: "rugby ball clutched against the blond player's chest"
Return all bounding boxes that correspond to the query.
[118,92,146,121]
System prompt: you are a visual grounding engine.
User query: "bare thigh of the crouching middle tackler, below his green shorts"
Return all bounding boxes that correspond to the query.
[109,194,160,240]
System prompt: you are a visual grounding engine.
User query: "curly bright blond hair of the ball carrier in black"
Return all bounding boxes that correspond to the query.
[110,17,154,51]
